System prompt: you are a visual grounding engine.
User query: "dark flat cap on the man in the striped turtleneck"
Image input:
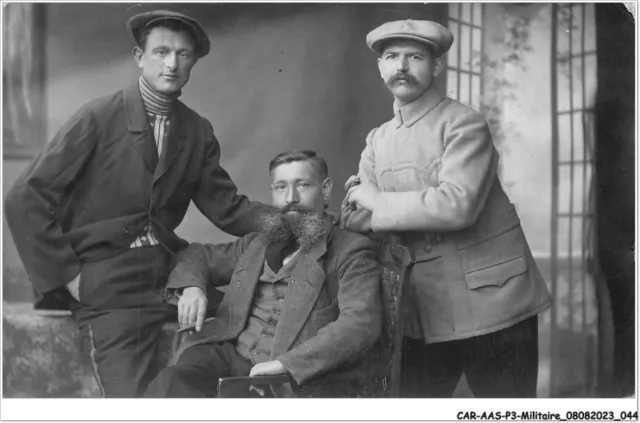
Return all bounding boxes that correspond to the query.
[127,10,211,58]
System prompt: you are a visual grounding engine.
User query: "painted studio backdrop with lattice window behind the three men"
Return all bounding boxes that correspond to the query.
[3,3,633,397]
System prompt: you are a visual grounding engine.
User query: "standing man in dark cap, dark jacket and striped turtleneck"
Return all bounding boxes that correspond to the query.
[5,10,270,397]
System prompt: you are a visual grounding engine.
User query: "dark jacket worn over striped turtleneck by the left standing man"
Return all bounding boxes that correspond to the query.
[5,83,265,306]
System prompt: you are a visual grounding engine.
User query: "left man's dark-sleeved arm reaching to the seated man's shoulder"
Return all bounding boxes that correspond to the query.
[193,121,271,236]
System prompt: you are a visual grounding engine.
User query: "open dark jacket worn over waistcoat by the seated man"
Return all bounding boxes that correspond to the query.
[167,228,383,383]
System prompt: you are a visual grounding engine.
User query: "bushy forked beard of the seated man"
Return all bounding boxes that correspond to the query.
[260,209,327,249]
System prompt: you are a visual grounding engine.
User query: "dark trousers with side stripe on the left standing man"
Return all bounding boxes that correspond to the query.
[71,246,177,398]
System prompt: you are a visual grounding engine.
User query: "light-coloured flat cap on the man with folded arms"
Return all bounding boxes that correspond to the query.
[367,19,453,57]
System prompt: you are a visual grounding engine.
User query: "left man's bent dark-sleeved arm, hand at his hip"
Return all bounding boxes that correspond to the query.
[5,108,96,304]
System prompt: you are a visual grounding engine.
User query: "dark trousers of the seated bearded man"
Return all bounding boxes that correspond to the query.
[145,342,253,398]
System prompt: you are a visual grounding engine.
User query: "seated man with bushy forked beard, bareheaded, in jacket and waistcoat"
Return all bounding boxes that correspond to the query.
[146,150,383,398]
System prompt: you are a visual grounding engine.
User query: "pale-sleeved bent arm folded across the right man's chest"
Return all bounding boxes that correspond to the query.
[347,112,498,231]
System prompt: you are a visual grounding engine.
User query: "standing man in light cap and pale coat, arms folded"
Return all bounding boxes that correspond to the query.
[342,20,551,397]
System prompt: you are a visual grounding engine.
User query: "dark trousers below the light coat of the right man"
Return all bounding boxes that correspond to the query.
[401,316,538,398]
